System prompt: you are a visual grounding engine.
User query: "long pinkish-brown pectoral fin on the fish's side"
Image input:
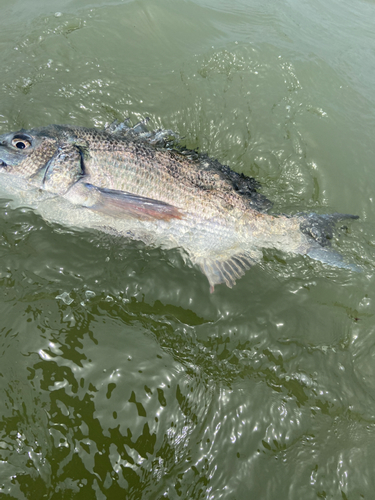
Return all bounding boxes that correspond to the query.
[66,182,182,221]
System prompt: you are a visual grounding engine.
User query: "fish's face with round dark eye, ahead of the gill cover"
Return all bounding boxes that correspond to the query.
[0,127,59,178]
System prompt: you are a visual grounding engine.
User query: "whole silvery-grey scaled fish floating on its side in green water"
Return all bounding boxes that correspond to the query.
[0,122,360,292]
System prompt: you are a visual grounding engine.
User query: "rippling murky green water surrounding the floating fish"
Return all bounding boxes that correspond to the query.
[0,0,375,500]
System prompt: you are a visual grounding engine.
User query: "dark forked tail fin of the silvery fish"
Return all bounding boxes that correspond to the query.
[300,213,361,272]
